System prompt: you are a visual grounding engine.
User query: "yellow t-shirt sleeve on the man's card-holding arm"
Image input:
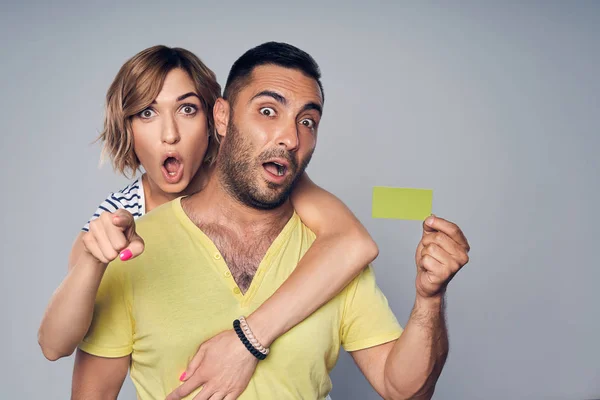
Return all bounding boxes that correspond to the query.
[341,266,402,352]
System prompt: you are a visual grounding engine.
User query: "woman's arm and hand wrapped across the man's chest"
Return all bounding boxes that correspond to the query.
[175,174,379,400]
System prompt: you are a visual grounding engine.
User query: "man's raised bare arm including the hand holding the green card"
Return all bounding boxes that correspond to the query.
[352,215,470,400]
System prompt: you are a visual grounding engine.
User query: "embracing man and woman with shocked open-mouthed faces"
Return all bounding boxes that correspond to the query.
[40,43,469,400]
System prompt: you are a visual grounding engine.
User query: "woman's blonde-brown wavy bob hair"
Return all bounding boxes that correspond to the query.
[98,45,221,176]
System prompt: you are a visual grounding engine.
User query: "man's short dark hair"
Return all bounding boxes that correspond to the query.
[223,42,325,104]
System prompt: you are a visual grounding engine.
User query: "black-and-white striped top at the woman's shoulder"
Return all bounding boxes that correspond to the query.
[81,178,146,232]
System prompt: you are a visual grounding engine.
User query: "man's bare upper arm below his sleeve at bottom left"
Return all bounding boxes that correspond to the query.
[71,349,131,400]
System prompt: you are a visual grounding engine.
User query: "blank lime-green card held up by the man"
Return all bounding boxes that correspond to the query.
[373,186,433,221]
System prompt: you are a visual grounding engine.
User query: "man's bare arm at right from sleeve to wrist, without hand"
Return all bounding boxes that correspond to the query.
[350,300,448,400]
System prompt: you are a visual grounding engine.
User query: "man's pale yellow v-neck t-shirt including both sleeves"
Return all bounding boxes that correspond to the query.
[80,199,402,400]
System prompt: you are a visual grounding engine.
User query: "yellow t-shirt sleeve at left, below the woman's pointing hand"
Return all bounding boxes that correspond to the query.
[79,261,133,358]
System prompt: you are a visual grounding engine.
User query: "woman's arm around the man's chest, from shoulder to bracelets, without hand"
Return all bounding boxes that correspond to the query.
[248,173,379,346]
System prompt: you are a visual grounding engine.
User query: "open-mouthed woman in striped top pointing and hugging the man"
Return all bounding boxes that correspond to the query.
[38,46,377,396]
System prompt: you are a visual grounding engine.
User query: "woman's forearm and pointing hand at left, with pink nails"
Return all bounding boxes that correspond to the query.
[38,209,144,361]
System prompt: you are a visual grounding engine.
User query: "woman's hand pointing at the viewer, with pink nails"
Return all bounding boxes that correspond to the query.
[83,209,144,265]
